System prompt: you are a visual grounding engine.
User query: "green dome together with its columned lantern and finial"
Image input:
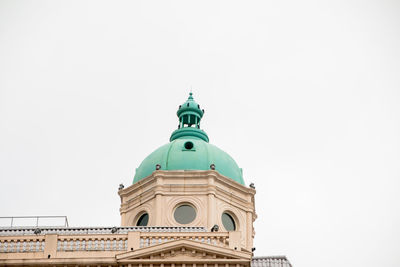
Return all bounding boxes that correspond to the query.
[133,93,244,185]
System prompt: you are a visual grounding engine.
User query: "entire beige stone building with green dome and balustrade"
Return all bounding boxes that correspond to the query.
[0,93,291,267]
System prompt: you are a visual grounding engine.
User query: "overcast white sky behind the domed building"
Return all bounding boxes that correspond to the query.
[0,0,400,267]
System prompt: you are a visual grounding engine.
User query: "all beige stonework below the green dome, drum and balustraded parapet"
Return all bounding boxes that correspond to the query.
[0,170,257,267]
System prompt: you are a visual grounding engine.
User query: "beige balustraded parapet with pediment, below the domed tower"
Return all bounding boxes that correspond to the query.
[0,232,251,267]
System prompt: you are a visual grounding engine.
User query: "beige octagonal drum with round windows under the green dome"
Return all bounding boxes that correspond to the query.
[119,170,256,250]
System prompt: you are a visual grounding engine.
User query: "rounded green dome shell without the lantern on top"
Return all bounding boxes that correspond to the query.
[133,137,244,185]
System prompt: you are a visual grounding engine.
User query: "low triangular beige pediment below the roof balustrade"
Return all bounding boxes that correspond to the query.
[116,240,251,263]
